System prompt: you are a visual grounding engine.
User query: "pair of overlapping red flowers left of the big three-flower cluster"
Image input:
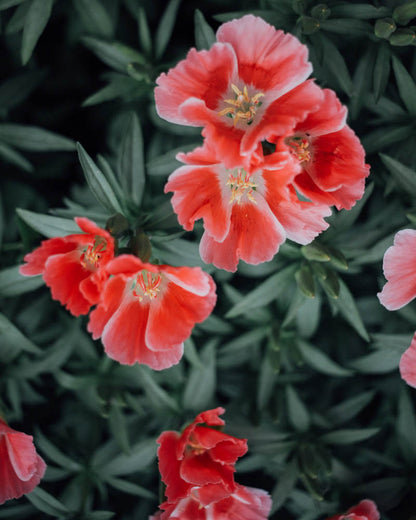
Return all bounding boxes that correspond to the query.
[20,217,216,370]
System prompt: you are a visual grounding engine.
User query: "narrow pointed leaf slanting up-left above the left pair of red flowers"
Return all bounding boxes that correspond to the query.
[77,143,123,214]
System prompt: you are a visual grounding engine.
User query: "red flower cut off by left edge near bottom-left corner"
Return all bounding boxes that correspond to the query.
[0,419,46,504]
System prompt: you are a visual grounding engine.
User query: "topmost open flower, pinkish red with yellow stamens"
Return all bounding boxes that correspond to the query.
[155,15,322,155]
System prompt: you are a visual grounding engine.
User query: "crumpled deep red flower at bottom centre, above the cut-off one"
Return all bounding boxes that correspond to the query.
[157,408,247,507]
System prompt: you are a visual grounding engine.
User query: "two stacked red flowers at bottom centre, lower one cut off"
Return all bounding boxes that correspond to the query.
[150,408,272,520]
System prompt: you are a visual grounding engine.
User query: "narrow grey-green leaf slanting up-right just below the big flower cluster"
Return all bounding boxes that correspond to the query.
[225,264,298,318]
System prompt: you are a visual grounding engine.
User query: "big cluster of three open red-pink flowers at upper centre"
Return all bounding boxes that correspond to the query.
[155,15,369,271]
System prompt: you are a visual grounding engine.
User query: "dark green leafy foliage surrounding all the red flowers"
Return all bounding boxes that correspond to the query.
[0,0,416,520]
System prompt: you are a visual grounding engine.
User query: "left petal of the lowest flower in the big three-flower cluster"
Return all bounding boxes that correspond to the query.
[165,166,231,242]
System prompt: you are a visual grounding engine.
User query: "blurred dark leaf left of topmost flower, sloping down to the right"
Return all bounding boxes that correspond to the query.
[82,36,146,72]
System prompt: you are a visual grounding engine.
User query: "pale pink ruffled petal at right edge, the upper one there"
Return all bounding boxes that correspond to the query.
[377,229,416,311]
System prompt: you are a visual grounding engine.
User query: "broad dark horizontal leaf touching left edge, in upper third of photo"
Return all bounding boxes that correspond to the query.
[0,123,75,152]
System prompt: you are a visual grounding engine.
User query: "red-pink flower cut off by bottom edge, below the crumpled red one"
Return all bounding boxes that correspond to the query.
[149,484,272,520]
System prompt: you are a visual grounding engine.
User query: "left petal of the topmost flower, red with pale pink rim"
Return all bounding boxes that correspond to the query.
[155,43,236,126]
